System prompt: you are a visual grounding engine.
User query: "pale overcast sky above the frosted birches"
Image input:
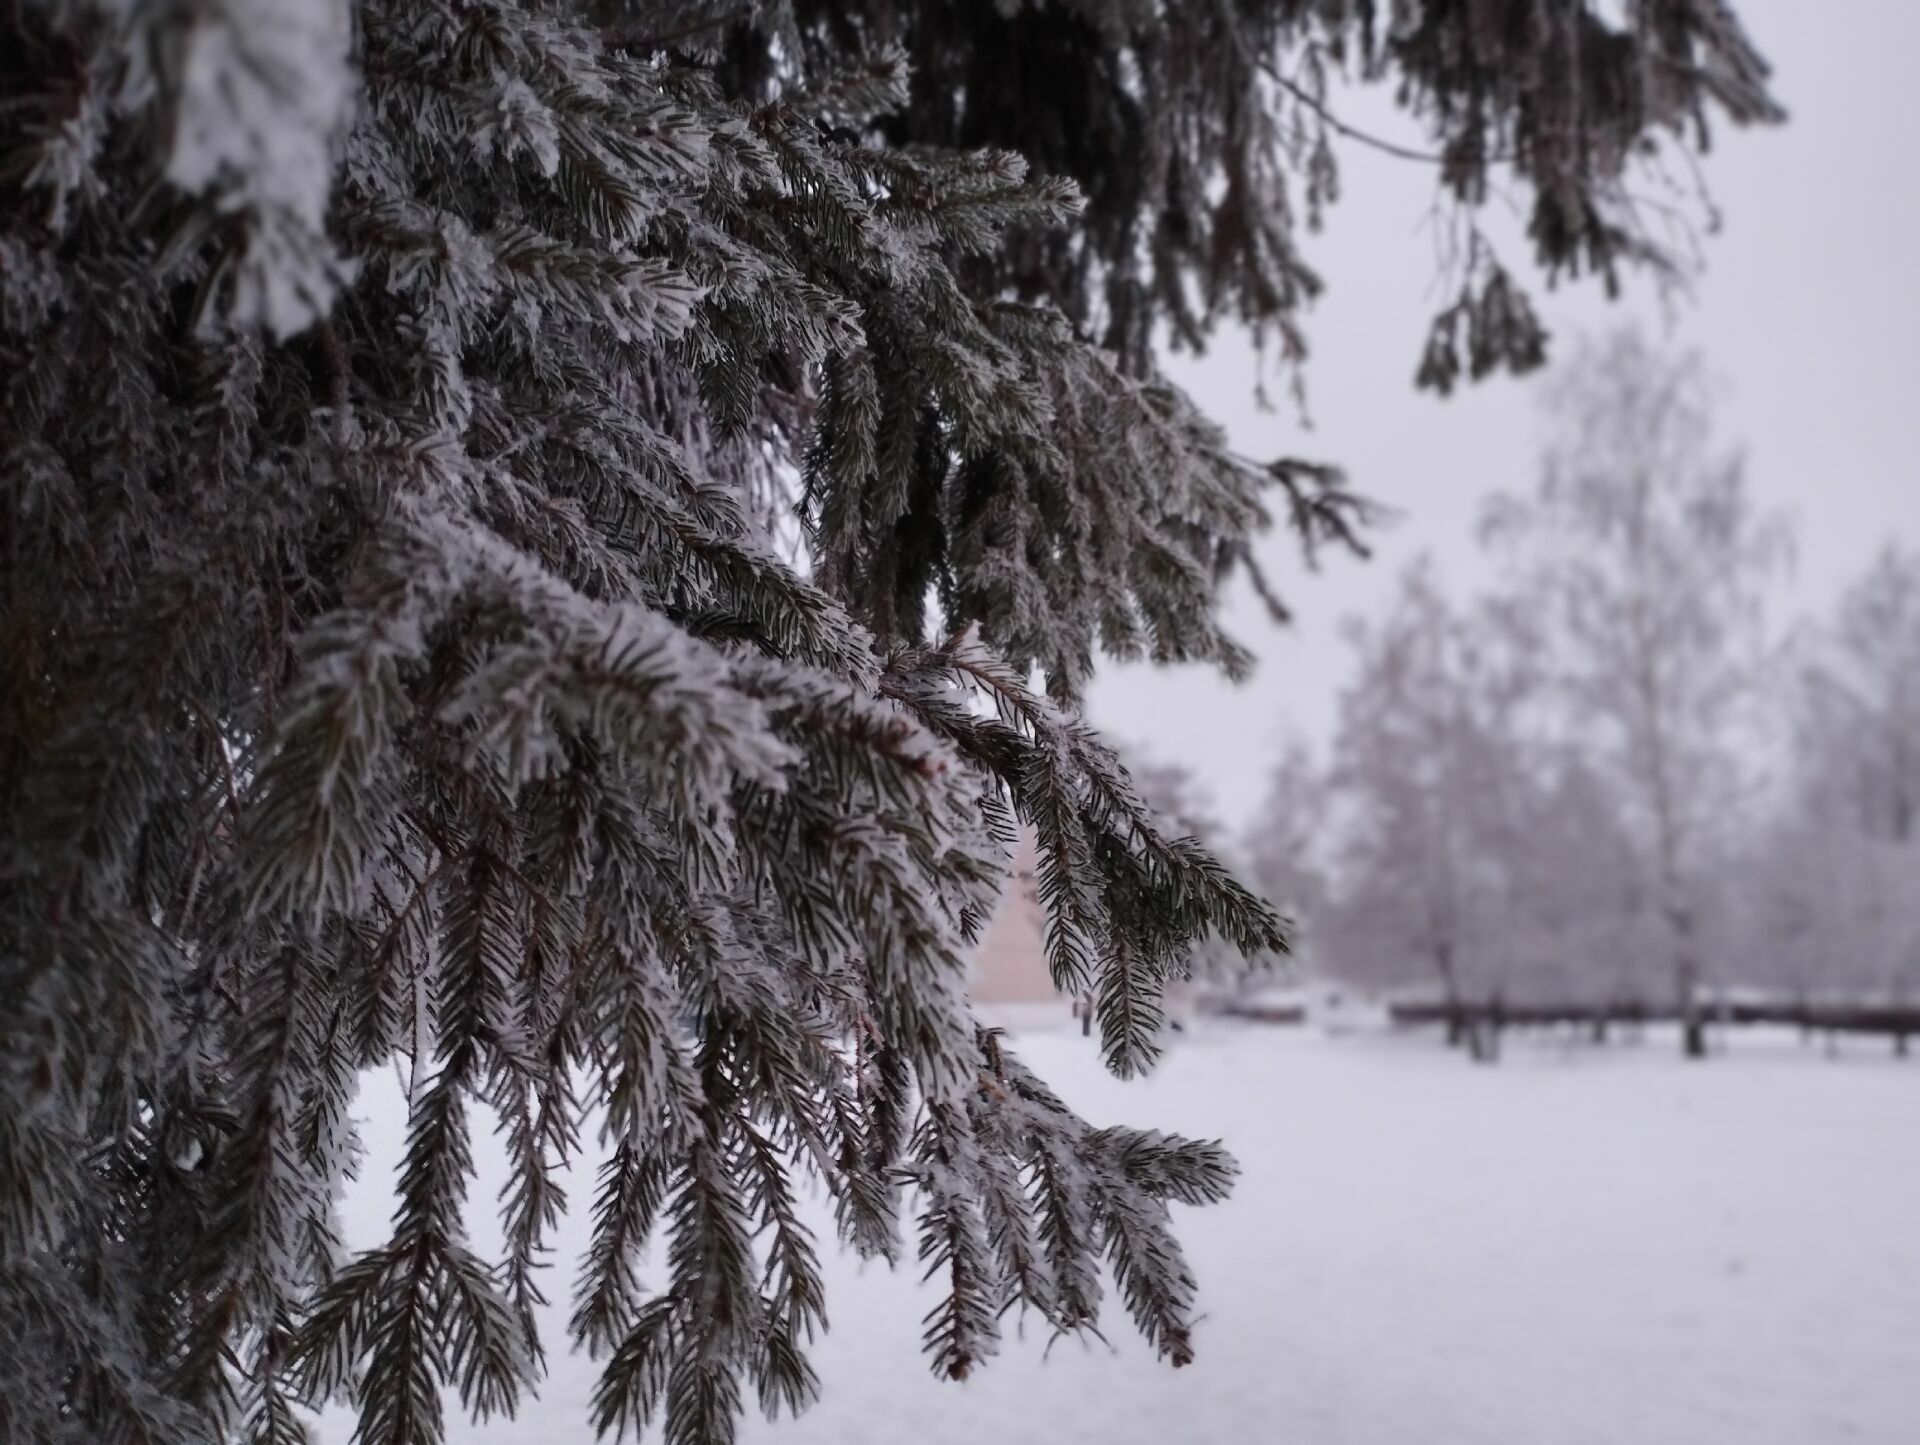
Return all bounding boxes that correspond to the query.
[1089,0,1920,825]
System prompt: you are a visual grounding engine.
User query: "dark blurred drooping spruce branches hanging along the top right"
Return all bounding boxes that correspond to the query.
[725,0,1782,391]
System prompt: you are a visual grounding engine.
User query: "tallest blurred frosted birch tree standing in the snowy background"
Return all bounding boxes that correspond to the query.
[1484,330,1786,1057]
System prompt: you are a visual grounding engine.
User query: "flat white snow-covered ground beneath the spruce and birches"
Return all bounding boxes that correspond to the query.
[328,1029,1920,1445]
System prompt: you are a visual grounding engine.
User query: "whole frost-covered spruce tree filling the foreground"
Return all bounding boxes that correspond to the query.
[0,0,1770,1445]
